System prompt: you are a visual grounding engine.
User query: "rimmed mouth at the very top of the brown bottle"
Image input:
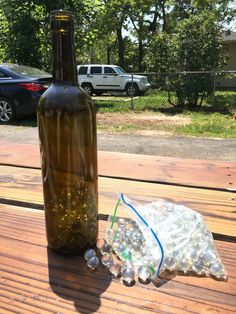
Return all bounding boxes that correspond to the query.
[50,10,74,31]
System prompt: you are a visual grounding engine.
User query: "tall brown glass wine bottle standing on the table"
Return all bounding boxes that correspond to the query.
[37,11,98,254]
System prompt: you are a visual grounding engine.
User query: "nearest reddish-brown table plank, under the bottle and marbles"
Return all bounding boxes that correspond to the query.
[0,205,236,314]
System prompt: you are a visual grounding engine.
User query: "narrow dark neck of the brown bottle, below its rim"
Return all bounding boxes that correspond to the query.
[52,28,78,85]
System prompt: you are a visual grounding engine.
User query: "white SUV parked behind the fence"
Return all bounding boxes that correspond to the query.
[77,64,150,96]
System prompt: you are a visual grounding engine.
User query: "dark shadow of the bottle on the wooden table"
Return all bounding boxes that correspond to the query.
[47,249,111,313]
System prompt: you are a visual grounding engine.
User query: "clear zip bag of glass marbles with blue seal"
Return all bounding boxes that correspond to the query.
[107,194,227,280]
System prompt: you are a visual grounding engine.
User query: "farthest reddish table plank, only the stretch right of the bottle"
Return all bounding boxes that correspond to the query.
[98,152,236,189]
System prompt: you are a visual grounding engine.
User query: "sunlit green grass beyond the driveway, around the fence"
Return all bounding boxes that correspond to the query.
[94,91,236,138]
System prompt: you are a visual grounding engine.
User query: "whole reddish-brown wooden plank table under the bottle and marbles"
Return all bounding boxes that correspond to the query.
[0,141,236,314]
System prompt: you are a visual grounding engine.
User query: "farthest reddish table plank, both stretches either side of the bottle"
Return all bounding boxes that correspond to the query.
[0,141,236,190]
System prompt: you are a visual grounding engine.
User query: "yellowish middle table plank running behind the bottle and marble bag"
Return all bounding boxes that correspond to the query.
[0,166,236,237]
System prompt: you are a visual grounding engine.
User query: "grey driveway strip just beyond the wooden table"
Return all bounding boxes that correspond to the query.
[0,125,236,162]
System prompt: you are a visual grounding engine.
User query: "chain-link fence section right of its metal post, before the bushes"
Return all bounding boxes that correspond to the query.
[130,71,236,109]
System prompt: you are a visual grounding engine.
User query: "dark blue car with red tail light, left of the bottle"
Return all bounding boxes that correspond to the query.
[0,64,52,123]
